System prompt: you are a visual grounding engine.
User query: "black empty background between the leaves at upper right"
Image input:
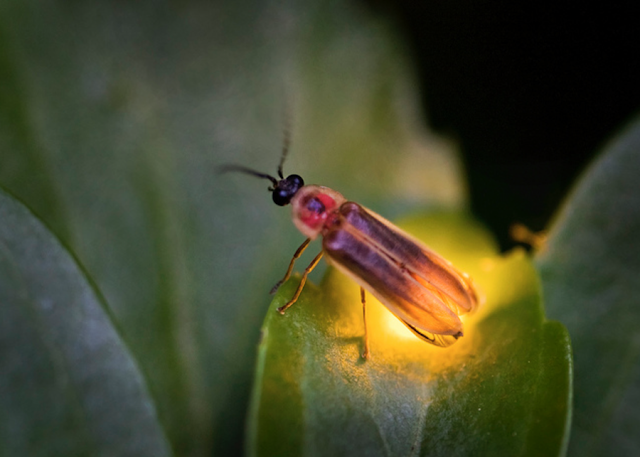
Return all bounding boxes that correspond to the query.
[370,0,640,249]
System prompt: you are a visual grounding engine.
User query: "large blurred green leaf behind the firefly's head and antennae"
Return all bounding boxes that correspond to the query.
[0,0,464,456]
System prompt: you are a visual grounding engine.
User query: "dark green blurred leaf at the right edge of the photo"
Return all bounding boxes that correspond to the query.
[536,115,640,457]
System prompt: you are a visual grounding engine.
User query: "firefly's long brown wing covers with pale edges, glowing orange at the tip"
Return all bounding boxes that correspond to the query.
[323,202,477,346]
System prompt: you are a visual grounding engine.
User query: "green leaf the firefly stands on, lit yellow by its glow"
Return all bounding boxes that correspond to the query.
[247,214,571,456]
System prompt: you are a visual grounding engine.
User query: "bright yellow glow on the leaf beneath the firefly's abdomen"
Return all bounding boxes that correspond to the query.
[301,214,526,388]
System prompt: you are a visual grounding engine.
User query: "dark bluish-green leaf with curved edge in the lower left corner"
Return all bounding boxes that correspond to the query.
[0,187,171,457]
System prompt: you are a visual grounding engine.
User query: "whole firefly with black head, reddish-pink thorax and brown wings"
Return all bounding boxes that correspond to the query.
[221,148,478,359]
